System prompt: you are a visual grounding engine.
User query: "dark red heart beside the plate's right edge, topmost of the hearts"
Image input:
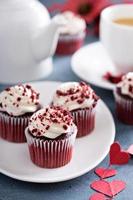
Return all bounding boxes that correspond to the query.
[110,142,130,165]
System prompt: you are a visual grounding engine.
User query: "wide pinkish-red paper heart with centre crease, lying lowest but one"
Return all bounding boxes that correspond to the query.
[90,180,126,197]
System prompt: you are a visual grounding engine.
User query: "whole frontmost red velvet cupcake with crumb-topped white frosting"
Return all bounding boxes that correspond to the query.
[25,106,77,168]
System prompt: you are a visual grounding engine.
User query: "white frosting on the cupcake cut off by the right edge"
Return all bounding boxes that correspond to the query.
[117,72,133,98]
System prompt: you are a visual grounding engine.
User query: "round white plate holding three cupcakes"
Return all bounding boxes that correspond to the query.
[0,82,115,183]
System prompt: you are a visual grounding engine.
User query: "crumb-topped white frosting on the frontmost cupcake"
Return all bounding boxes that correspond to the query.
[28,107,74,139]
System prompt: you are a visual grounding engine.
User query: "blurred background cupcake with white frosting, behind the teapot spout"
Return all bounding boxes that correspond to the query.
[56,11,86,55]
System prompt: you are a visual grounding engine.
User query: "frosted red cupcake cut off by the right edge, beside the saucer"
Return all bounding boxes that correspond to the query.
[114,72,133,125]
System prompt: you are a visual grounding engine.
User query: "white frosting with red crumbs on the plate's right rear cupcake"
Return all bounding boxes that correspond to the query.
[53,82,98,111]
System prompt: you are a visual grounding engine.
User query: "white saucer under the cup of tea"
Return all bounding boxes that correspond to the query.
[71,42,115,90]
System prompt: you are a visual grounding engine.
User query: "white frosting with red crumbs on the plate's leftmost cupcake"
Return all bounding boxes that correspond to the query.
[0,85,39,116]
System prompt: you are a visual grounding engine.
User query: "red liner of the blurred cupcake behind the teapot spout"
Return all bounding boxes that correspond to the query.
[56,34,85,55]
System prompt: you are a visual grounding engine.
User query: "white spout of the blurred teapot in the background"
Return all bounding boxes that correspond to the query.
[32,16,66,61]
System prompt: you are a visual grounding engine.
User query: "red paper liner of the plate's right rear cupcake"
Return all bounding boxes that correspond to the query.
[71,108,95,137]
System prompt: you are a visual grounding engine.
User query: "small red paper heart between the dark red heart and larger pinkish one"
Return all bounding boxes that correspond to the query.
[95,167,117,179]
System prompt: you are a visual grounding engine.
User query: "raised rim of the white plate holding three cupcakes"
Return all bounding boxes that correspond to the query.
[0,81,116,183]
